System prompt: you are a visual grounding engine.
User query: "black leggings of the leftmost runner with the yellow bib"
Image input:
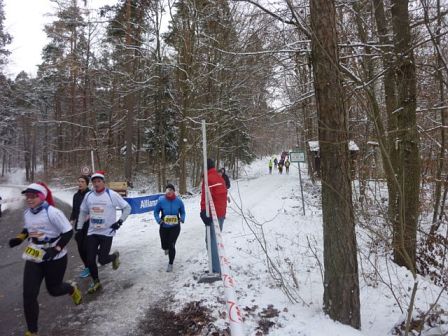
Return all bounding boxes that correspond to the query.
[23,255,73,333]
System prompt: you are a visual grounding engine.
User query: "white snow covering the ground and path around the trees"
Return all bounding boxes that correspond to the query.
[2,160,448,336]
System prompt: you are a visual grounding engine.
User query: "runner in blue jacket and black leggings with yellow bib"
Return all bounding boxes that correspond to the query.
[154,183,185,272]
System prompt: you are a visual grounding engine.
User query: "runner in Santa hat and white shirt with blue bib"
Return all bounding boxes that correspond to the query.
[78,171,131,294]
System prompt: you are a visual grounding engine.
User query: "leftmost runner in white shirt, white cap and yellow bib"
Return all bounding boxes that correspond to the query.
[9,183,82,336]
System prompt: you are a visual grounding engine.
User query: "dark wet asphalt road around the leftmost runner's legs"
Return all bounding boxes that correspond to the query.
[0,196,82,336]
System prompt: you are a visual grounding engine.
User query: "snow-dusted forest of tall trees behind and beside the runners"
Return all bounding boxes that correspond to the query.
[0,0,448,334]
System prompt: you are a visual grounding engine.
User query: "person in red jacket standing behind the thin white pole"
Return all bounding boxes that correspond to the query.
[201,159,227,273]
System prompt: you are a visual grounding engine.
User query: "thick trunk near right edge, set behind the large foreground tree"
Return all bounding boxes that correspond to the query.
[391,0,420,272]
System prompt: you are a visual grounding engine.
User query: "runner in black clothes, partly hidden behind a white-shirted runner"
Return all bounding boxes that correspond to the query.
[70,175,90,278]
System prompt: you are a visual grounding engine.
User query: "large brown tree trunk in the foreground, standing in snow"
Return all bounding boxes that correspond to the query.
[310,0,361,328]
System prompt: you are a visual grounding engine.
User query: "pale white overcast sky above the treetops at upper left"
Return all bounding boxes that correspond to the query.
[3,0,118,78]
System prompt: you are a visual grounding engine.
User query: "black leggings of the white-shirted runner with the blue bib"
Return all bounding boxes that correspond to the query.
[87,235,116,280]
